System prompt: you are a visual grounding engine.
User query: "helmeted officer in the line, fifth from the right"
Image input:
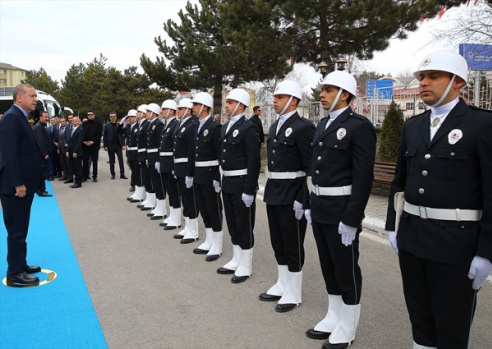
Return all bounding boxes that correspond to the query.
[192,92,223,262]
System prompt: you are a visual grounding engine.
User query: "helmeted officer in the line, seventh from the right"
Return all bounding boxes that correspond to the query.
[155,99,181,230]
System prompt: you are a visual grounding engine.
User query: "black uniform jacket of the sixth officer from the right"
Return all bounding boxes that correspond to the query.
[173,116,197,178]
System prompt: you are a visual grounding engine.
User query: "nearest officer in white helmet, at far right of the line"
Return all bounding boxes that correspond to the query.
[386,51,492,349]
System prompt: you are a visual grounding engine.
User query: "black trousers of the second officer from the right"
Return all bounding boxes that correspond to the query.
[313,220,362,305]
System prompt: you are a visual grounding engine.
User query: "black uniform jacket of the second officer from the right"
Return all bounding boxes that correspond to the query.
[310,108,376,227]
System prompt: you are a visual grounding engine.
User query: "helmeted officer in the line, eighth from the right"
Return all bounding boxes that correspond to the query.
[147,103,167,220]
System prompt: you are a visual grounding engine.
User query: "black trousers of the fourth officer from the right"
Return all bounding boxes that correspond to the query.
[222,192,256,250]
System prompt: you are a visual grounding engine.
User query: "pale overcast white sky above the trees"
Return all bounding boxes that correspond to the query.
[0,0,472,86]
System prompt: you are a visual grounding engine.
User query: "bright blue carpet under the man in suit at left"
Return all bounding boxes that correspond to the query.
[0,182,107,349]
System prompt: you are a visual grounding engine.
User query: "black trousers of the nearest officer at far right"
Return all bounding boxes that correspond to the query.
[398,249,476,349]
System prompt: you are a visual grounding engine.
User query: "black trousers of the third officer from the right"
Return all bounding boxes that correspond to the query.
[267,205,307,272]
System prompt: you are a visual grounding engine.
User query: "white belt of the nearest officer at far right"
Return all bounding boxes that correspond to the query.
[403,201,482,222]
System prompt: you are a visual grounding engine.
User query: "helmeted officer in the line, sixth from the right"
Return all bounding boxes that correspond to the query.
[173,98,199,244]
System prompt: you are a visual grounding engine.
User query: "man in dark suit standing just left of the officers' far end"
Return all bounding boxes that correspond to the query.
[103,113,127,179]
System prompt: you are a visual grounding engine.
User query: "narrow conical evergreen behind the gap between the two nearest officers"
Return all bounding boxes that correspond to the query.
[378,102,403,162]
